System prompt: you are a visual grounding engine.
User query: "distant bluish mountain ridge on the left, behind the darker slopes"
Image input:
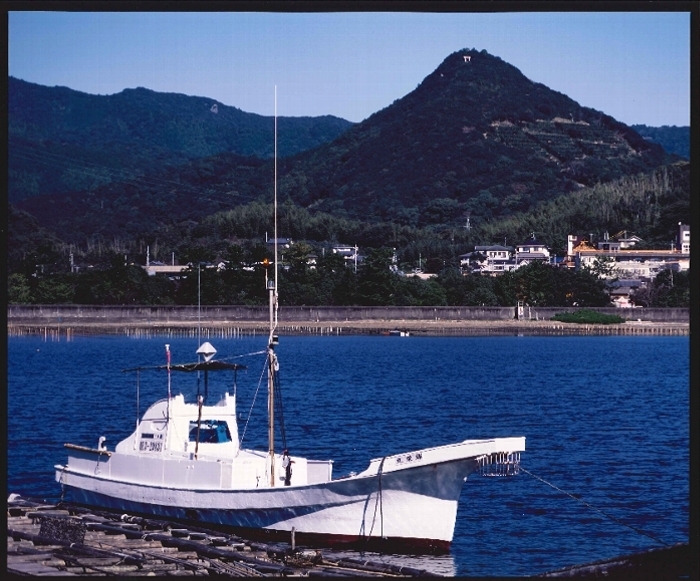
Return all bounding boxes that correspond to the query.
[7,77,352,202]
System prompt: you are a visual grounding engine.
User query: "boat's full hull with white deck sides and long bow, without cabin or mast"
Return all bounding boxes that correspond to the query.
[56,437,525,553]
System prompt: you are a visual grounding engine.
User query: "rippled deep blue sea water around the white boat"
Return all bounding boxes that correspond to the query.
[7,336,690,576]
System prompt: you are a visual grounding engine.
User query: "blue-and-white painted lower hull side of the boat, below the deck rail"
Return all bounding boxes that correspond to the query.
[60,459,477,552]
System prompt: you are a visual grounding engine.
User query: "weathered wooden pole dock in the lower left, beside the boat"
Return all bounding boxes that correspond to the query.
[7,495,437,577]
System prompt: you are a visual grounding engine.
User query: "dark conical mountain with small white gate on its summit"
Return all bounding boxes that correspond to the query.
[280,50,668,225]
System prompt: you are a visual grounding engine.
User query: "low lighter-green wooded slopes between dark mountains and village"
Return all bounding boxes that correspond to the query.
[8,162,690,273]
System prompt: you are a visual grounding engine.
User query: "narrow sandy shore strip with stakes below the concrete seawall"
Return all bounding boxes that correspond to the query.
[7,319,690,338]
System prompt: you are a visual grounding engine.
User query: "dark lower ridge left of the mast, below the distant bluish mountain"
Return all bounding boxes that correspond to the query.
[16,153,273,245]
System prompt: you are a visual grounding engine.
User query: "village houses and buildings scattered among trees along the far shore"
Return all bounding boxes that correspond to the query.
[143,222,690,308]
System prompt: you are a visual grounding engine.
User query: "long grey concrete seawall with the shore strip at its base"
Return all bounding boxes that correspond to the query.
[7,305,690,337]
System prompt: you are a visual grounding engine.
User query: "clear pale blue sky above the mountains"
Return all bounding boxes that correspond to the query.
[8,9,690,126]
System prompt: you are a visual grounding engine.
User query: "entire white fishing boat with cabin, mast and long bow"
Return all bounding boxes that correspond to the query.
[55,92,525,553]
